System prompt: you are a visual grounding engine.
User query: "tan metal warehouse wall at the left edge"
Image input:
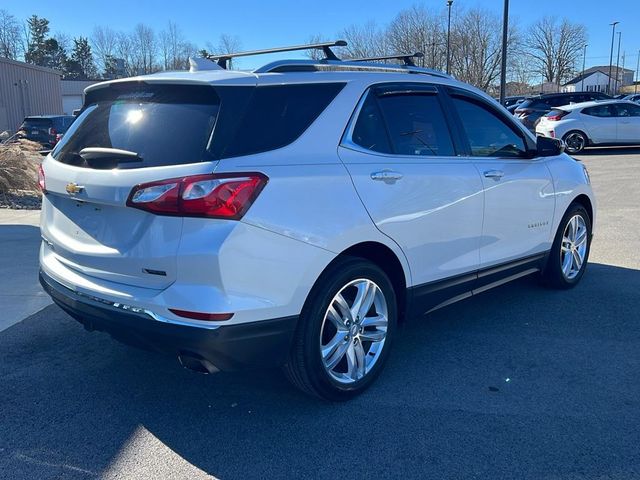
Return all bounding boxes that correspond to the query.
[0,58,62,132]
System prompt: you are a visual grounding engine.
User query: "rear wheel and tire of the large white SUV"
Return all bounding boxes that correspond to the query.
[283,257,398,401]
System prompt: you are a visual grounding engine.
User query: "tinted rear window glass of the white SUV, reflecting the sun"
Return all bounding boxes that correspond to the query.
[53,85,220,168]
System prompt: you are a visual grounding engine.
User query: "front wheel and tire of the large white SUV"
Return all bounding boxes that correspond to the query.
[542,203,591,289]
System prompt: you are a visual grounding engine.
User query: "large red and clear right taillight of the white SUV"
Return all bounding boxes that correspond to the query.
[127,172,269,220]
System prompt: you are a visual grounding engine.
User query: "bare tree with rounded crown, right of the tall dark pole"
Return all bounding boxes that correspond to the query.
[527,16,587,85]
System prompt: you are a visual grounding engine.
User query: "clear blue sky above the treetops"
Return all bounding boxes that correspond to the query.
[6,0,640,73]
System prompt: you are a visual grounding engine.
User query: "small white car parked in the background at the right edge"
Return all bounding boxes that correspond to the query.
[536,100,640,153]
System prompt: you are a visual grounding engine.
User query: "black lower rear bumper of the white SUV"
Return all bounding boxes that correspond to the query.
[40,271,298,370]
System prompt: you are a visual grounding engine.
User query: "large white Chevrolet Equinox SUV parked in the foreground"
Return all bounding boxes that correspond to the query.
[40,43,595,400]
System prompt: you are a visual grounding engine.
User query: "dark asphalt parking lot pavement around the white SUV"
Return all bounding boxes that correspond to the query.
[0,149,640,479]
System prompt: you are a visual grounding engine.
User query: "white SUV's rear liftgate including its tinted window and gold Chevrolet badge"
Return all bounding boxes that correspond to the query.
[41,82,225,289]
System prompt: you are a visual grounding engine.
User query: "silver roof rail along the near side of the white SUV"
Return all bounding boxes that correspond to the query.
[253,59,453,78]
